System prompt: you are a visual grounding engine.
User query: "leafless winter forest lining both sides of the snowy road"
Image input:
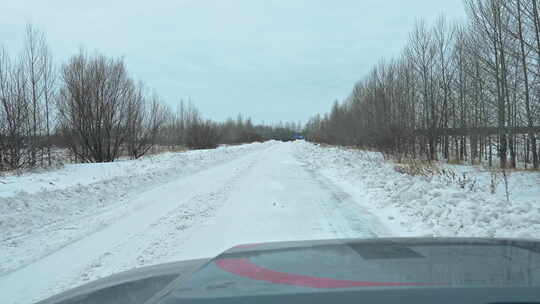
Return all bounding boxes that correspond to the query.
[0,0,540,171]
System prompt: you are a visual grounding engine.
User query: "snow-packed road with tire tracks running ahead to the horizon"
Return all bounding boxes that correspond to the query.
[0,143,375,304]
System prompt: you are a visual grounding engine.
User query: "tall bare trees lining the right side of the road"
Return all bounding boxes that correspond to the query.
[306,0,540,168]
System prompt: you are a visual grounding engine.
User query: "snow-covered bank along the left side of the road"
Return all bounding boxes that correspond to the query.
[0,142,275,275]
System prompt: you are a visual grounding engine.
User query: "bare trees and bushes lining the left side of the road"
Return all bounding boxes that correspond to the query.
[0,25,300,171]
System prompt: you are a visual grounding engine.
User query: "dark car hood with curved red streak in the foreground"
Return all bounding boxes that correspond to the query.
[35,238,540,304]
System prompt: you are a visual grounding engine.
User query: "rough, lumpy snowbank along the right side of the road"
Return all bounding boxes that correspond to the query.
[296,142,540,238]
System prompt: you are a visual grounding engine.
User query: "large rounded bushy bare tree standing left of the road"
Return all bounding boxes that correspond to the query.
[57,51,137,162]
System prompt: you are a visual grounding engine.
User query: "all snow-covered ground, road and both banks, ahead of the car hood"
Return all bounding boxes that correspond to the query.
[0,141,540,304]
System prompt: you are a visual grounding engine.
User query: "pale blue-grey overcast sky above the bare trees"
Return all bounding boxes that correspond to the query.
[0,0,465,122]
